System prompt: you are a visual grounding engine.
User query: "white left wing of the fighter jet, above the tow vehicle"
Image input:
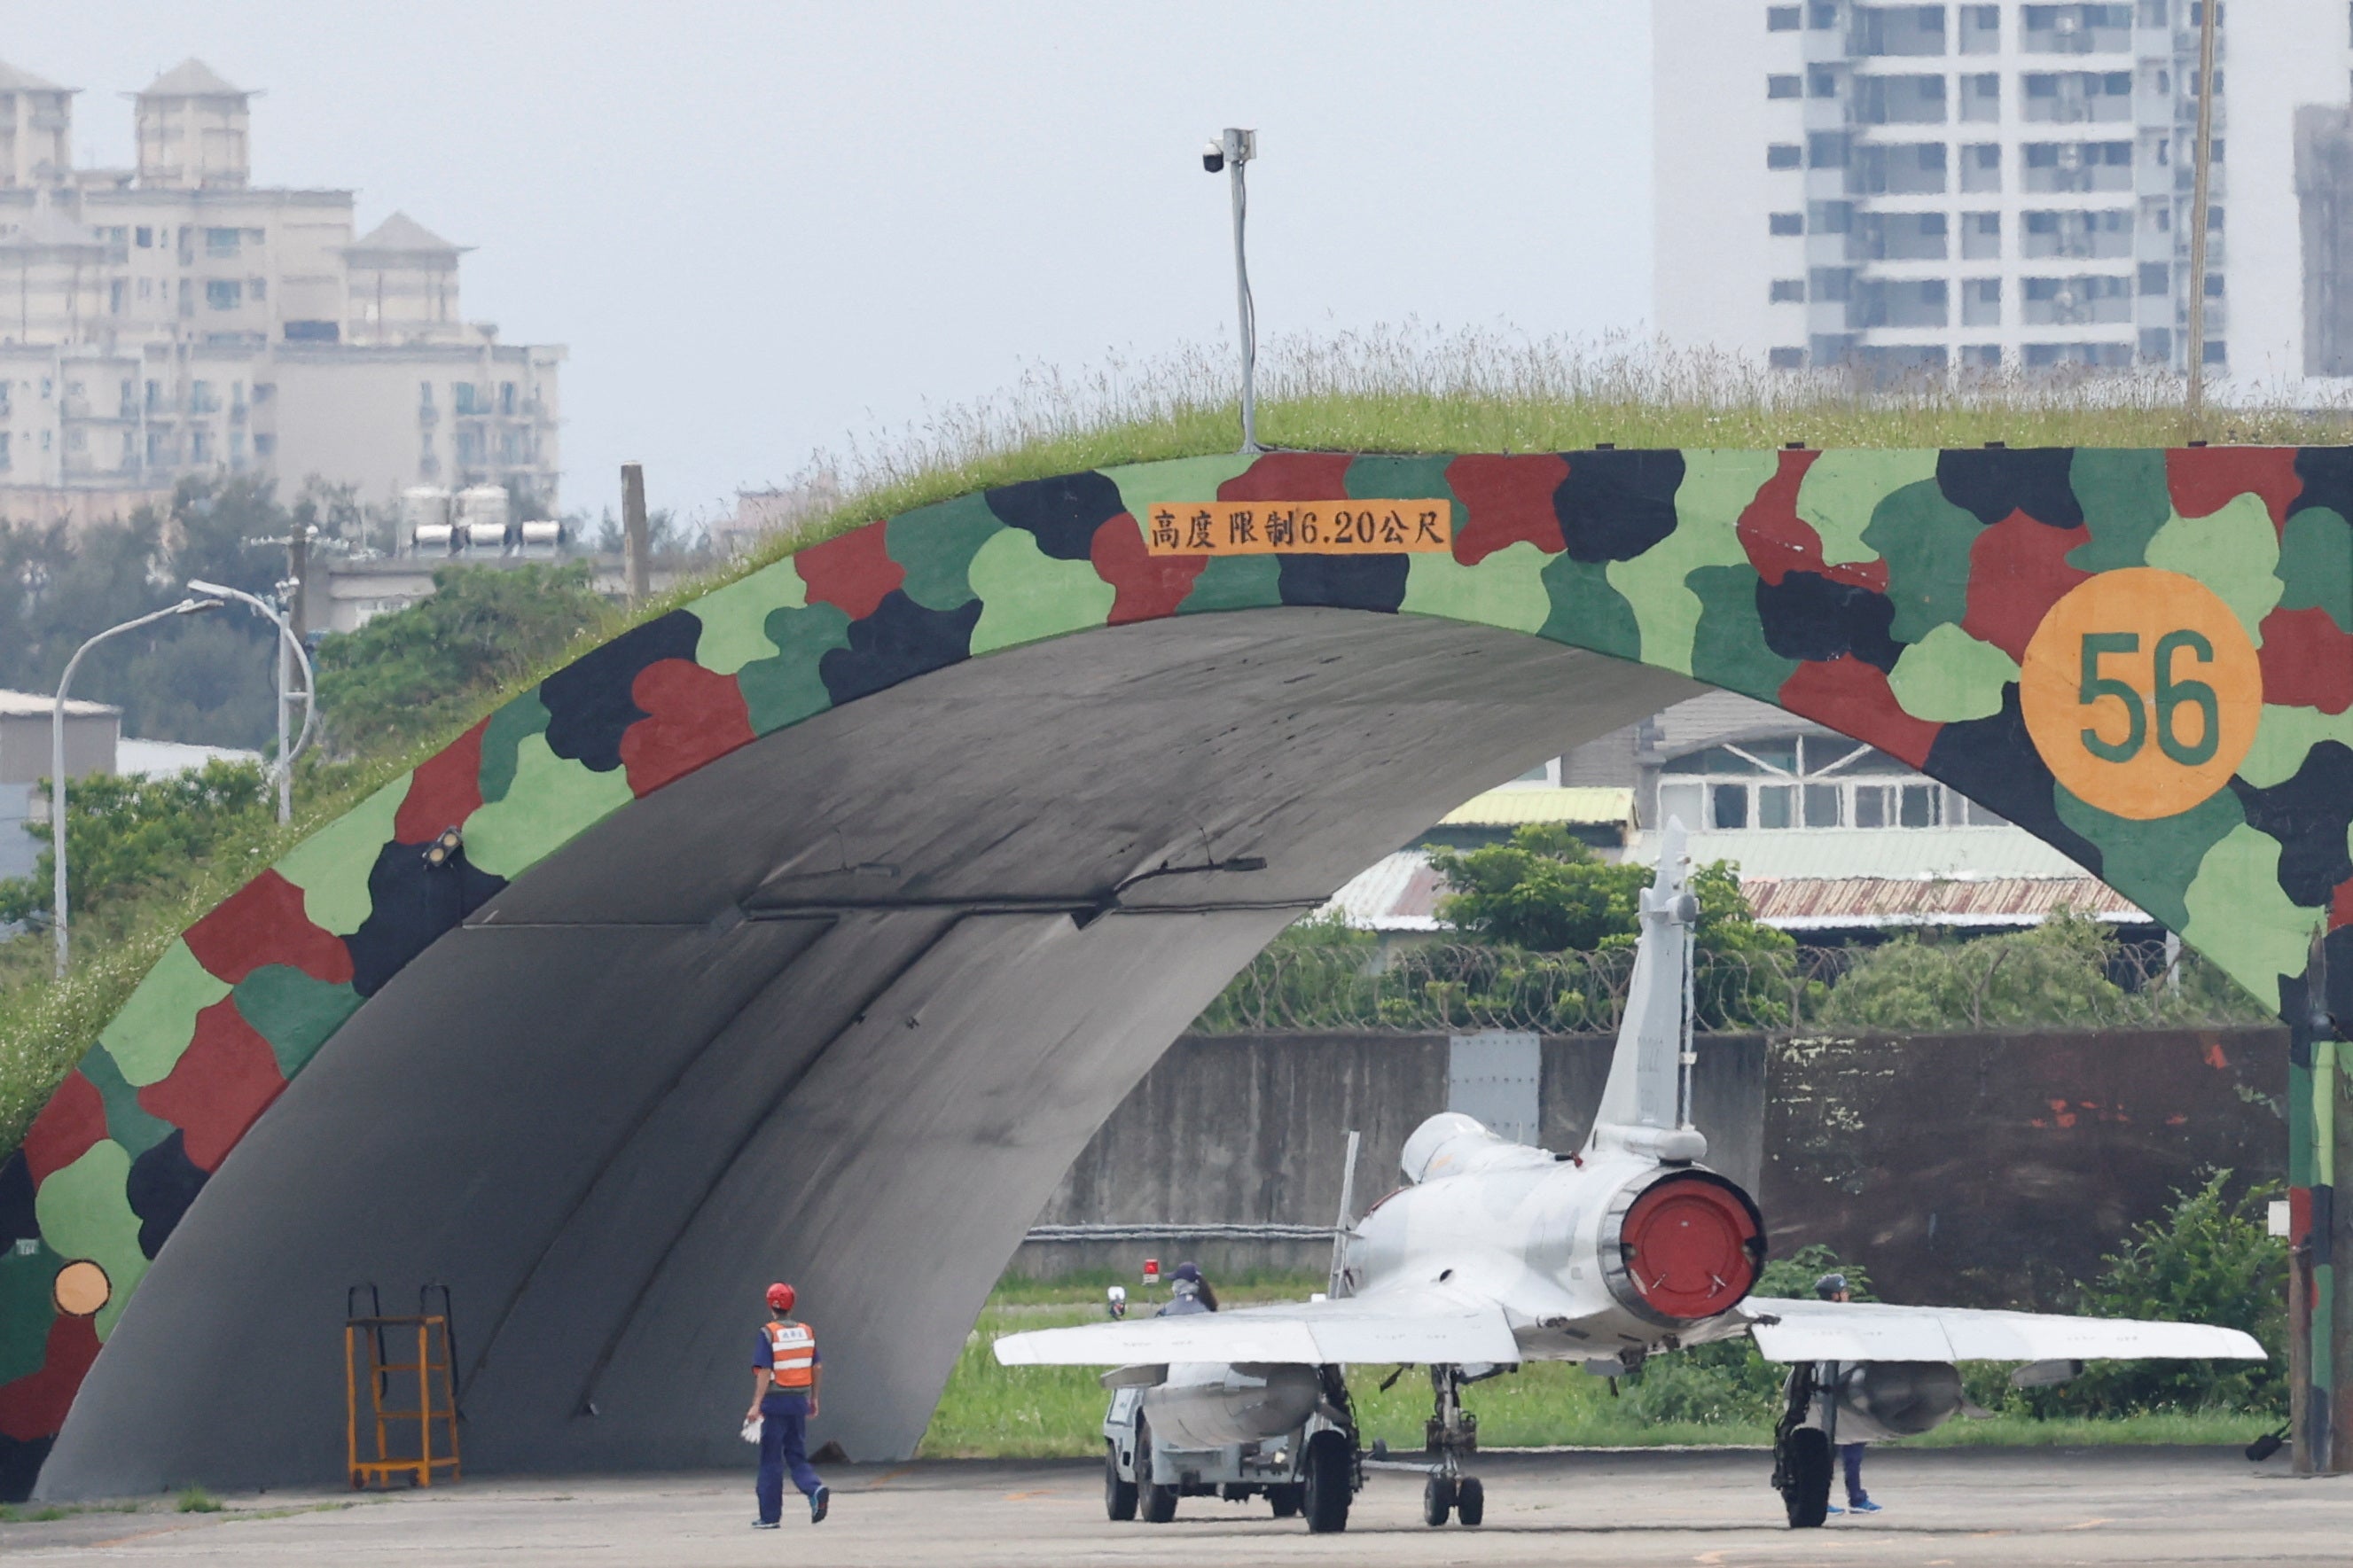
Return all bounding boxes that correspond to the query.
[996,1291,1520,1366]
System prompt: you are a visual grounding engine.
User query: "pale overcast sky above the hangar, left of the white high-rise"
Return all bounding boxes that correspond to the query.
[0,0,1649,527]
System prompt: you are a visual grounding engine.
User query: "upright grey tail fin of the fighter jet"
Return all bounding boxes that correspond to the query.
[1588,818,1708,1161]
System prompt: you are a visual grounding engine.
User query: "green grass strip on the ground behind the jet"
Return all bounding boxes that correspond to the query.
[918,1279,2271,1457]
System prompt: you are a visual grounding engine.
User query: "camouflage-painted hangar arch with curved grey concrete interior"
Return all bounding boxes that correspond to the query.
[0,449,2353,1495]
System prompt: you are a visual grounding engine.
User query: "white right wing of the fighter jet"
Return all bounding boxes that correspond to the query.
[1741,1295,2263,1361]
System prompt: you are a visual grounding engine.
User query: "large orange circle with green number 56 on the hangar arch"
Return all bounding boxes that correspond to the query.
[2019,566,2263,823]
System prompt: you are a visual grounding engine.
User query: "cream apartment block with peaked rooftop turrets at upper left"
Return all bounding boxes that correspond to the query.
[0,61,565,522]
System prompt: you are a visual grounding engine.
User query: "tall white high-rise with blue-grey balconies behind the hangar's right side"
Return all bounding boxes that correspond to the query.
[1654,0,2353,388]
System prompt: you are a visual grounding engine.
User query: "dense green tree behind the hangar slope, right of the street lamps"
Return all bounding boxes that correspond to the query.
[316,562,612,757]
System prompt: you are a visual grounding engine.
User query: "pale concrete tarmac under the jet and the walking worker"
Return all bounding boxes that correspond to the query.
[0,1448,2353,1568]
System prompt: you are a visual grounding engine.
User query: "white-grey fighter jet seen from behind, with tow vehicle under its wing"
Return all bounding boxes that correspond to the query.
[996,821,2263,1531]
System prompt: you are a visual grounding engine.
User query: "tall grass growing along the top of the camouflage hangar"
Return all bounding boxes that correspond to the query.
[0,324,2353,1152]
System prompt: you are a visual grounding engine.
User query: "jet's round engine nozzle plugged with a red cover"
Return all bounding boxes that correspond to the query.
[1600,1168,1765,1323]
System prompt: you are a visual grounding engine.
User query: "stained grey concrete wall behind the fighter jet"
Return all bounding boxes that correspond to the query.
[1012,1027,2287,1307]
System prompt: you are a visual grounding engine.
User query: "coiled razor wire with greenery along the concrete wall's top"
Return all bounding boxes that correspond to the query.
[1193,938,2273,1034]
